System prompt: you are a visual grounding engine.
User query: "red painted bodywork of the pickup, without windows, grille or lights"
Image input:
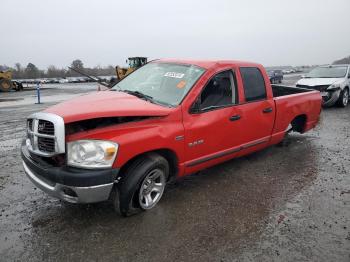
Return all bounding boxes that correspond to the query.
[46,60,321,176]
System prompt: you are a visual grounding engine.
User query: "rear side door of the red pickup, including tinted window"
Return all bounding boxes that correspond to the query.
[239,67,276,149]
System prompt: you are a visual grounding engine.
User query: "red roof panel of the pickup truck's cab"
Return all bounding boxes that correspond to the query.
[152,59,262,69]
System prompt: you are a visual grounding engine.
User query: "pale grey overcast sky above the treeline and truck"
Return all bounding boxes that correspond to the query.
[0,0,350,68]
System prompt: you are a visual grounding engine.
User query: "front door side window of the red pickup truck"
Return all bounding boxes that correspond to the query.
[199,70,237,110]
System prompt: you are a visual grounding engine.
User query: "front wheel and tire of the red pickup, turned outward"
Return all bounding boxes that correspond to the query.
[111,153,169,216]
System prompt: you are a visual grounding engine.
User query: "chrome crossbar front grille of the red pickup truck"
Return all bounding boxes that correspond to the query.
[26,113,65,156]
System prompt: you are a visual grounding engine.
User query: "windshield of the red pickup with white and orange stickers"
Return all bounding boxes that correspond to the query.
[111,63,205,106]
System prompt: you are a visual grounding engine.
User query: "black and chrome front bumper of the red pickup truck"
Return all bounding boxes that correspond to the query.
[22,146,118,203]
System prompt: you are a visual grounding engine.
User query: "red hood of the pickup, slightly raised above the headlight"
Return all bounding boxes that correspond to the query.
[44,91,172,123]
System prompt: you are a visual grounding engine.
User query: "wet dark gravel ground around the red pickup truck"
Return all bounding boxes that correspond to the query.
[0,81,350,262]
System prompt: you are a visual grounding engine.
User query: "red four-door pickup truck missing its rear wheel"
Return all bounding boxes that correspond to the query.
[21,60,322,215]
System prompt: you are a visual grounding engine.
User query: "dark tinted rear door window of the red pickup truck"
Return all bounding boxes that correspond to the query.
[239,67,266,102]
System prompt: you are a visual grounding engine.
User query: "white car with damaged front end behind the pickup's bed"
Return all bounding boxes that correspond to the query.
[296,65,350,107]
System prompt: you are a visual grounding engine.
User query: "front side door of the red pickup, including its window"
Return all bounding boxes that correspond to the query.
[183,70,241,173]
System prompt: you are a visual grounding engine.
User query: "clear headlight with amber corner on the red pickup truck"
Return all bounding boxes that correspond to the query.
[67,140,118,169]
